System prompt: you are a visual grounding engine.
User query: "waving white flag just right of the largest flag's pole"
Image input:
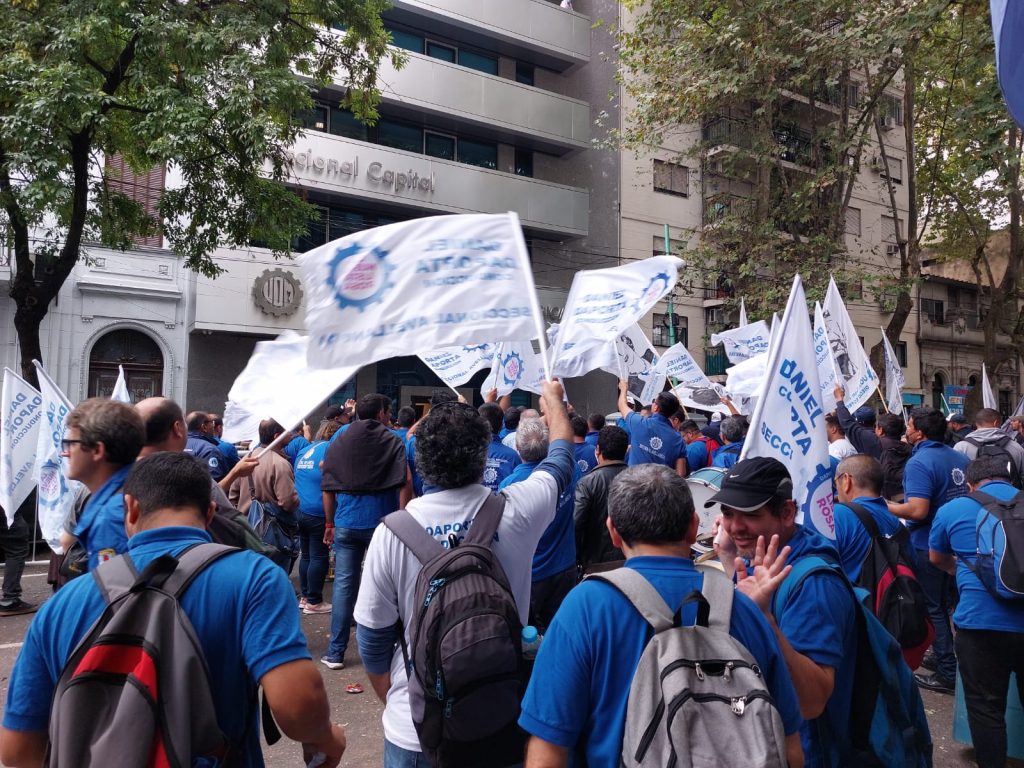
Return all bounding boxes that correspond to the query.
[552,256,683,370]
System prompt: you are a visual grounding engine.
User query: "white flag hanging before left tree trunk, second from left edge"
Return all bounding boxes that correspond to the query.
[32,360,82,555]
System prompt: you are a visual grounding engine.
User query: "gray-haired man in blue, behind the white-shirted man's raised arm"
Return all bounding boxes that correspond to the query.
[498,419,581,634]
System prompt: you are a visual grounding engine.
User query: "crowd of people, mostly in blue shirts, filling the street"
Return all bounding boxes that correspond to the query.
[0,381,1024,768]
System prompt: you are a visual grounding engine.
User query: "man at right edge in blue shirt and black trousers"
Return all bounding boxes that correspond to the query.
[928,456,1024,768]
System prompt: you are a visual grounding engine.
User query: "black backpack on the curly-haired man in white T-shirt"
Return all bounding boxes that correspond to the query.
[384,495,526,768]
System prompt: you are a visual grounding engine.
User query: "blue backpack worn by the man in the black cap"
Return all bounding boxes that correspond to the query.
[772,555,932,768]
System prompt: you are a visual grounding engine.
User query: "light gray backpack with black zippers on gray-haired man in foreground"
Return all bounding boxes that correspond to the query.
[587,566,786,768]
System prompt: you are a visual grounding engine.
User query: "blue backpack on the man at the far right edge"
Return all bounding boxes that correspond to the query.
[964,490,1024,600]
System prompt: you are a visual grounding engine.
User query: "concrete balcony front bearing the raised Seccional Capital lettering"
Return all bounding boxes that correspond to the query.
[289,131,590,237]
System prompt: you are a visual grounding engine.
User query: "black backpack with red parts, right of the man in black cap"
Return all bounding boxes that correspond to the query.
[846,502,935,670]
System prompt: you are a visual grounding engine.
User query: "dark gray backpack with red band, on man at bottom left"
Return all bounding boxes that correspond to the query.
[47,544,238,768]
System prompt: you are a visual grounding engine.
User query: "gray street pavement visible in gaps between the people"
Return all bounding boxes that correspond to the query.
[0,565,1024,768]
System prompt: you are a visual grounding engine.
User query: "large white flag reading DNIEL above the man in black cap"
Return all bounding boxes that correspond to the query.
[741,274,836,539]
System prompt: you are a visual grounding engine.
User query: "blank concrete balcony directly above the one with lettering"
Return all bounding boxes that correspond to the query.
[381,51,590,155]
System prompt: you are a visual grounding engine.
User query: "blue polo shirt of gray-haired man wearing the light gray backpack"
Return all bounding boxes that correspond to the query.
[519,557,801,766]
